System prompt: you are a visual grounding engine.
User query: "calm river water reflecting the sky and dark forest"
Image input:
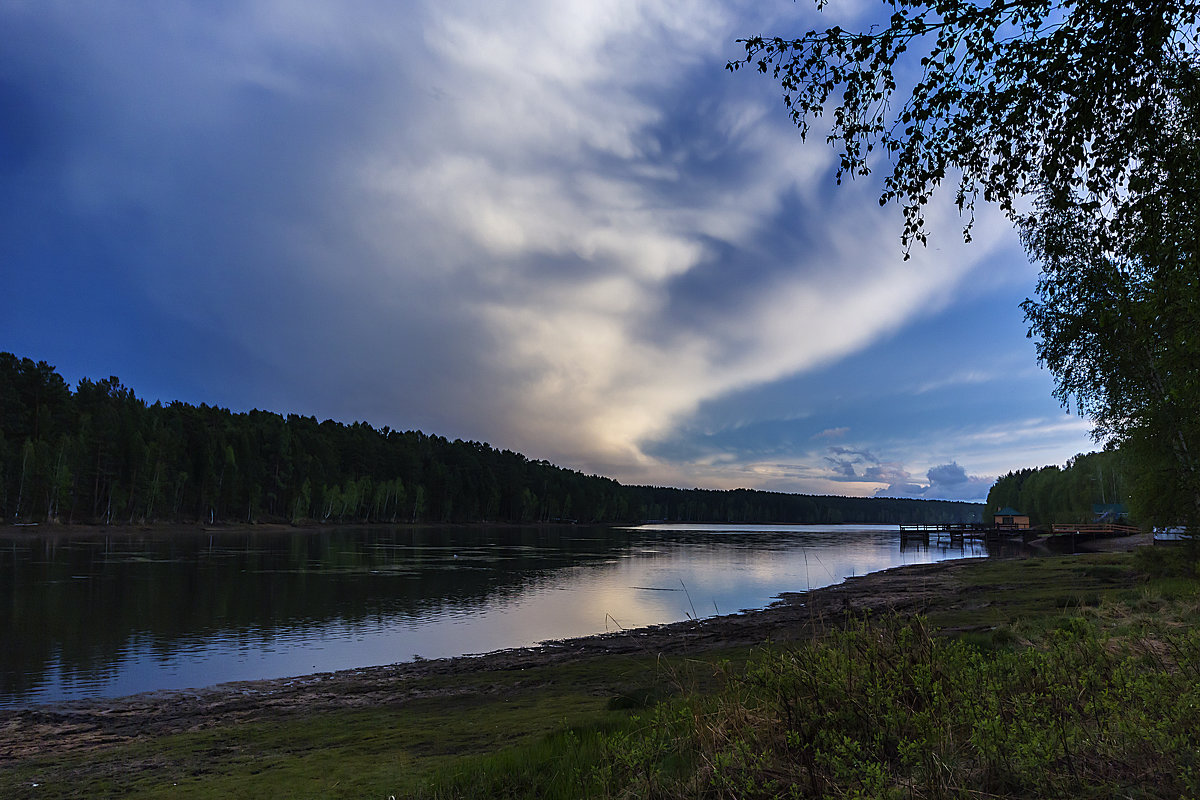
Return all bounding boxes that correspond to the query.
[0,524,986,706]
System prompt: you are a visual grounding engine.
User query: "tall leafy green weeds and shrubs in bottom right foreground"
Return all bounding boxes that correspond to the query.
[583,618,1200,798]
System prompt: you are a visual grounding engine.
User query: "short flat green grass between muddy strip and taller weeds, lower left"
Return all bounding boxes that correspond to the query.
[0,649,746,799]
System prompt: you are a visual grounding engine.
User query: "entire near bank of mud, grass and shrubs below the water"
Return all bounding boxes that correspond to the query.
[0,536,1200,798]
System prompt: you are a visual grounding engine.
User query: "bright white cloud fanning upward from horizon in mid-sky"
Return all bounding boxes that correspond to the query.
[274,2,1032,480]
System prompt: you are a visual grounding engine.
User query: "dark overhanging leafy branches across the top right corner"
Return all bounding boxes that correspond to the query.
[727,0,1200,254]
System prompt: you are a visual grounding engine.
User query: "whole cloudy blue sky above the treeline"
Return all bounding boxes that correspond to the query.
[0,0,1094,500]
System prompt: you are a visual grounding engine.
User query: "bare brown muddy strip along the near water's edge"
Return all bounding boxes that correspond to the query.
[0,559,973,763]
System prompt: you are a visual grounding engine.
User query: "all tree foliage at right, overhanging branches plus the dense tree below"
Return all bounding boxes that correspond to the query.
[728,0,1200,525]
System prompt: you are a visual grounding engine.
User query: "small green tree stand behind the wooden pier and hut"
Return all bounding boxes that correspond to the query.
[986,451,1128,525]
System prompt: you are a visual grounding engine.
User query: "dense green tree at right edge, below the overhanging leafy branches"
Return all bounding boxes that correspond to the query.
[1022,62,1200,524]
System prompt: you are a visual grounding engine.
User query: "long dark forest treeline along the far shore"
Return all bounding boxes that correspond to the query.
[0,353,982,523]
